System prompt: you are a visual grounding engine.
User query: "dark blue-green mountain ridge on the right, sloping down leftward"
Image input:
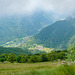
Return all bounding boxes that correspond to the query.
[20,18,75,49]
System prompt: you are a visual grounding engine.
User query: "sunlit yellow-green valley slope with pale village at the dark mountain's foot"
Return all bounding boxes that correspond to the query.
[19,37,54,53]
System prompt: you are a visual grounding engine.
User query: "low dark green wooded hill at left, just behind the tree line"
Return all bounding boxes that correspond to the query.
[0,46,31,55]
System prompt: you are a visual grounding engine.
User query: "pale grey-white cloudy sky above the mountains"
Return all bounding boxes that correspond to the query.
[0,0,75,16]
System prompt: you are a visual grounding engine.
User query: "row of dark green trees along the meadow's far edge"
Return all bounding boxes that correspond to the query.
[0,50,67,63]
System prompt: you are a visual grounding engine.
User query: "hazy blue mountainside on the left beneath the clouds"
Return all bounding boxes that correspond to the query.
[0,12,54,45]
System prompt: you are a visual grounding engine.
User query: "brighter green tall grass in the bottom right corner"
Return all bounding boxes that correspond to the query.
[23,64,75,75]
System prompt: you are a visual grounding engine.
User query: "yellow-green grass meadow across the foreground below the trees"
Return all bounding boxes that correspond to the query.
[0,62,75,75]
